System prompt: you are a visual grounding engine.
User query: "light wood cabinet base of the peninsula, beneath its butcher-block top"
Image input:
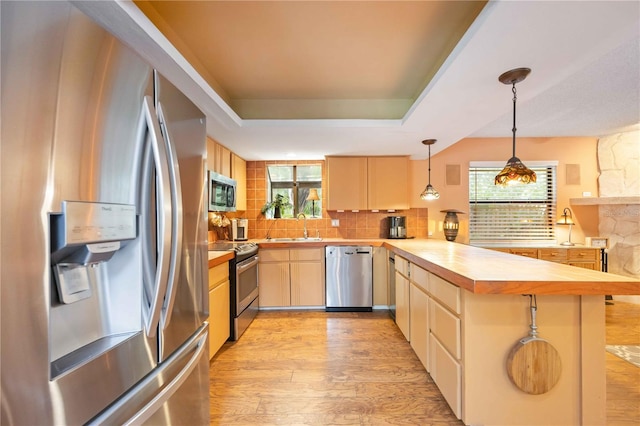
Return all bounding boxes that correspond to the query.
[395,253,606,426]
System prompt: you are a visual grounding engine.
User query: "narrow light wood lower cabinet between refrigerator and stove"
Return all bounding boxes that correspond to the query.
[209,262,231,359]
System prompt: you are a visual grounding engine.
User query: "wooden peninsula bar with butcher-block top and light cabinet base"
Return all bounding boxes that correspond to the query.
[384,240,640,425]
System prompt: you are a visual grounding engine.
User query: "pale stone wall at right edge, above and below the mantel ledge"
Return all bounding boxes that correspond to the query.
[598,131,640,290]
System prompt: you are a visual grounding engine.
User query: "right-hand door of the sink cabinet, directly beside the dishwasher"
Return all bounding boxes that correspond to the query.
[290,262,325,306]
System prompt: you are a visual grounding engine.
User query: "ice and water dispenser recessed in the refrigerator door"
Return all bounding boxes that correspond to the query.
[49,201,142,377]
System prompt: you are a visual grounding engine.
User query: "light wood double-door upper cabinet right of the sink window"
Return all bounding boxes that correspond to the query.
[326,156,409,210]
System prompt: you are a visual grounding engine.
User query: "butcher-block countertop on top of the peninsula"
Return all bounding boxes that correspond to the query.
[385,239,640,295]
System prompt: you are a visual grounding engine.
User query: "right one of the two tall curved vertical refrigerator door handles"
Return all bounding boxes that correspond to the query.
[158,103,182,329]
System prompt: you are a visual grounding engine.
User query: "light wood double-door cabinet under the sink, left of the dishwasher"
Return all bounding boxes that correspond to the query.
[258,248,325,307]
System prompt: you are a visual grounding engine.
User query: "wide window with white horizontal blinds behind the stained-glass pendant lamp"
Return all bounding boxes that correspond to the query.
[469,162,557,246]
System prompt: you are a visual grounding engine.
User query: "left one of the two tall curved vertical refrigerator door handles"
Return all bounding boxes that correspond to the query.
[141,96,171,337]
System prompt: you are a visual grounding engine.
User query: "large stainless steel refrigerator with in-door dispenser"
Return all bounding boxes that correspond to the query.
[0,0,209,426]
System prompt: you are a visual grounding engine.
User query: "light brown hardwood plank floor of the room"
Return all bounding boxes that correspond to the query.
[210,302,640,426]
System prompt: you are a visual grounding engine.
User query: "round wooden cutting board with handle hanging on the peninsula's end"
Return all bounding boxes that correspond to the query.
[507,294,562,395]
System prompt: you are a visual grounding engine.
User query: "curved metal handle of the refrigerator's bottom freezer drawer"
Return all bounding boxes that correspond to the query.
[87,322,209,425]
